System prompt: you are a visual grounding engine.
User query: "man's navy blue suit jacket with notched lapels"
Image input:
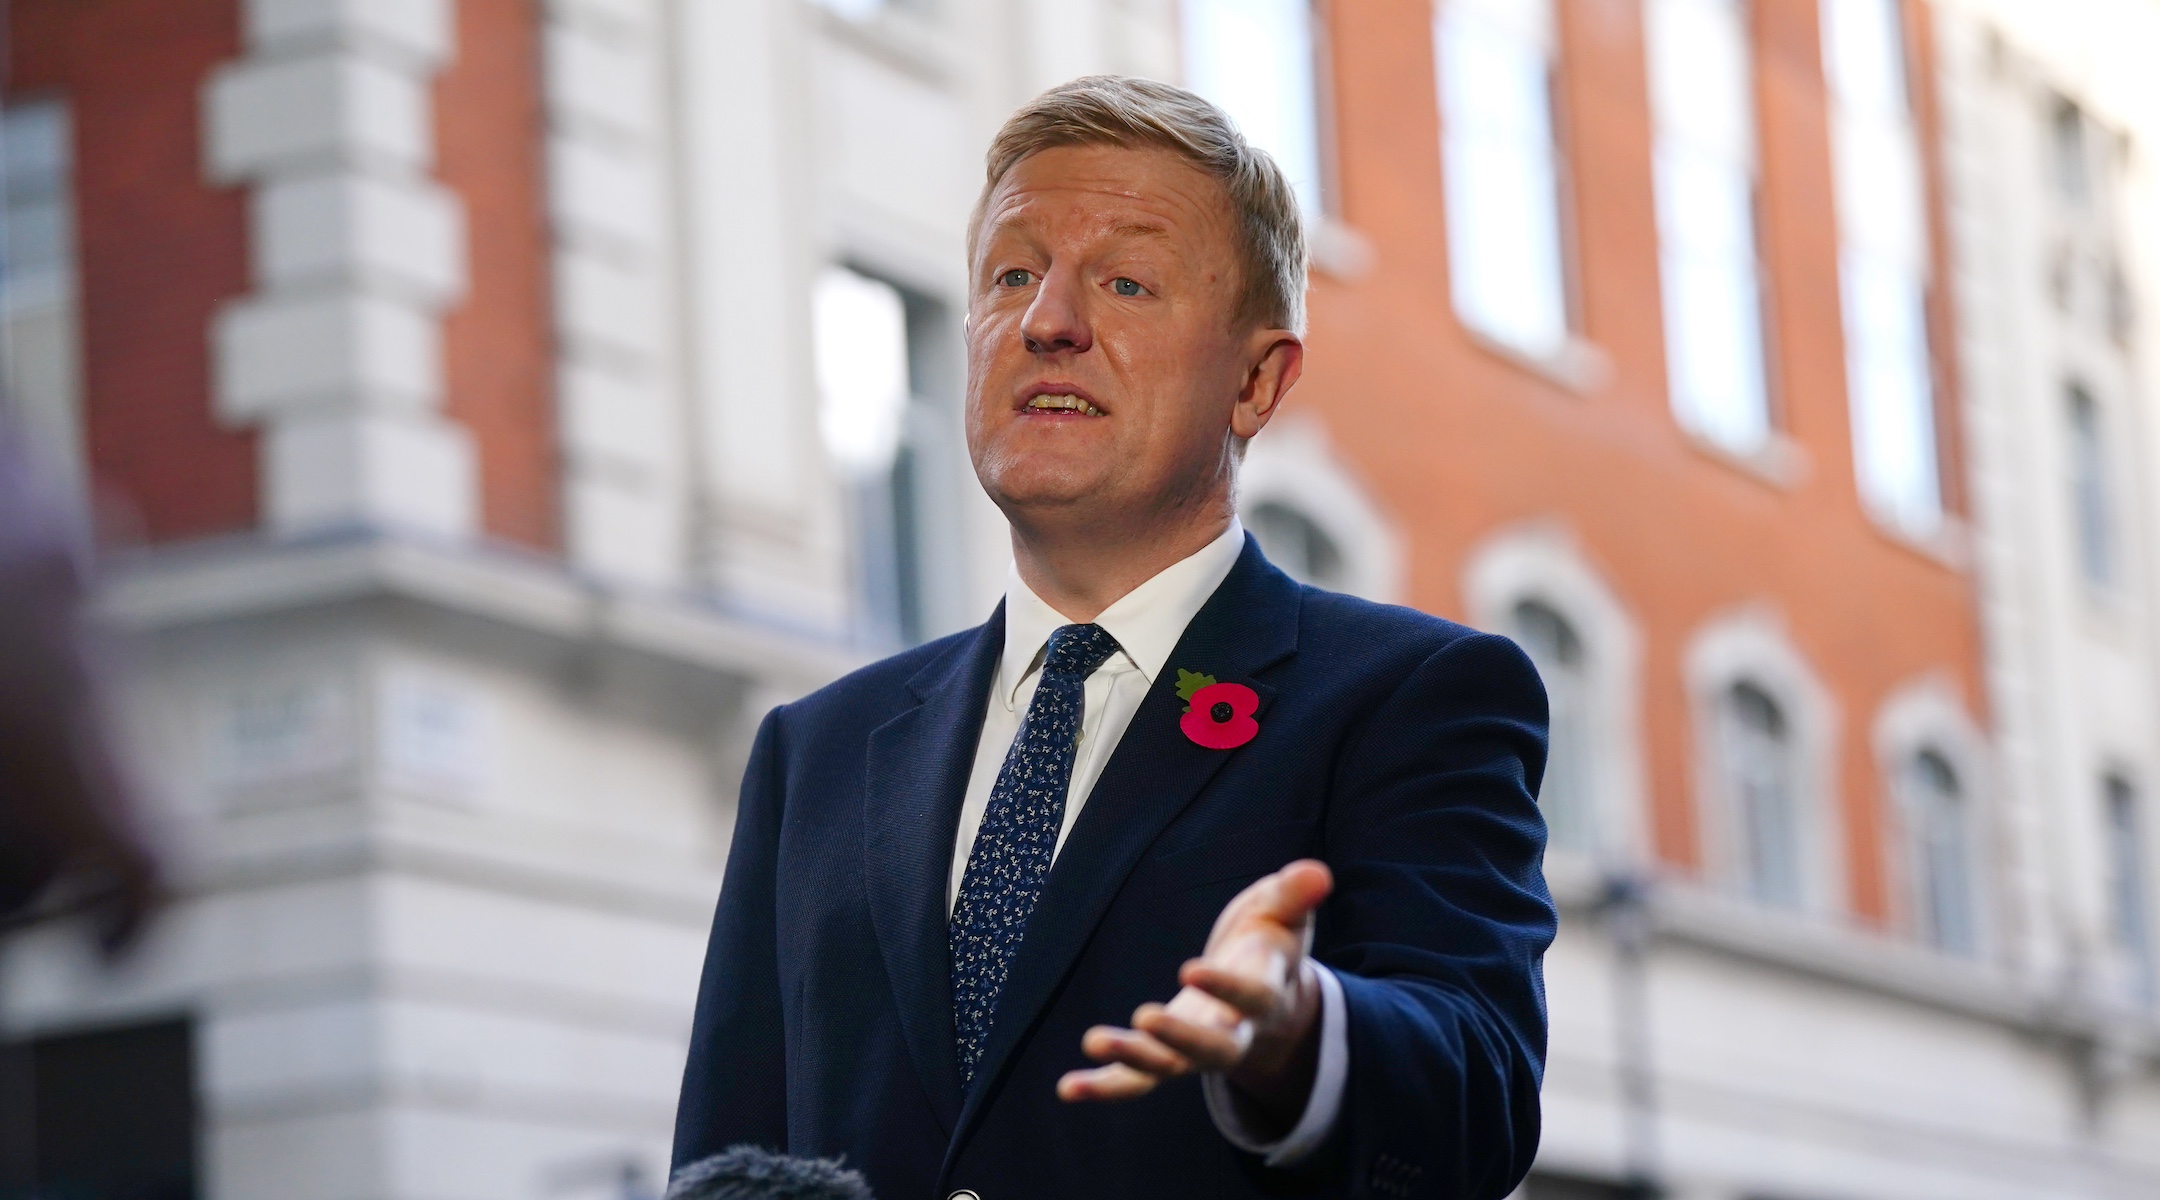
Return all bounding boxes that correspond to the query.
[674,540,1555,1200]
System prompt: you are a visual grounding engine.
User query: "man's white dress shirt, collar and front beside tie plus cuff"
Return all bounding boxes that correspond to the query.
[946,518,1350,1165]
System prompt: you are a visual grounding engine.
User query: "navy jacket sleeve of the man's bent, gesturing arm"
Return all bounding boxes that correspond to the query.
[1261,635,1555,1200]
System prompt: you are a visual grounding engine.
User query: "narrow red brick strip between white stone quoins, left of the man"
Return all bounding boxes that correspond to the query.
[434,0,562,550]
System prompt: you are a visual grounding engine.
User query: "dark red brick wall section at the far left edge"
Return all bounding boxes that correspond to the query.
[9,0,257,540]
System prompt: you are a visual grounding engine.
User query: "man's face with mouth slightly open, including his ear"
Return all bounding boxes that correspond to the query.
[968,147,1300,524]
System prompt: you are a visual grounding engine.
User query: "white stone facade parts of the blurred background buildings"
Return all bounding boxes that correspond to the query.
[12,0,2160,1200]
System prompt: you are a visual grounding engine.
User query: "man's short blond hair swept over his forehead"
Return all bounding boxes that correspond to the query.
[968,76,1305,335]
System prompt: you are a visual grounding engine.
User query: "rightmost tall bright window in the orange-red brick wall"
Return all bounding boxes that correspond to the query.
[1823,0,1942,537]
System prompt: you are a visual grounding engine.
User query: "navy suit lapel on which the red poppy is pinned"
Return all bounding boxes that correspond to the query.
[953,537,1300,1153]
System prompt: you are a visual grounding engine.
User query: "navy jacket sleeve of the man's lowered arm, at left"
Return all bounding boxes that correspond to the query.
[674,708,788,1170]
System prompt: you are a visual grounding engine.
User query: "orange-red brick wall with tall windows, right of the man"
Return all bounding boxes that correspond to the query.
[1292,0,1981,919]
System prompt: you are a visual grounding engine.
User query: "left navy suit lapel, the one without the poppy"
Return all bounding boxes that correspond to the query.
[862,604,1004,1133]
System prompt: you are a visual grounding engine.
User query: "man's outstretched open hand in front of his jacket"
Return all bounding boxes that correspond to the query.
[1058,859,1335,1129]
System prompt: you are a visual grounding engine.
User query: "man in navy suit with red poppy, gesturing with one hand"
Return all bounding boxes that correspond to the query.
[674,76,1555,1200]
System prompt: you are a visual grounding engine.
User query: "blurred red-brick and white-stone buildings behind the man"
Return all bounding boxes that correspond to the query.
[0,0,2160,1200]
